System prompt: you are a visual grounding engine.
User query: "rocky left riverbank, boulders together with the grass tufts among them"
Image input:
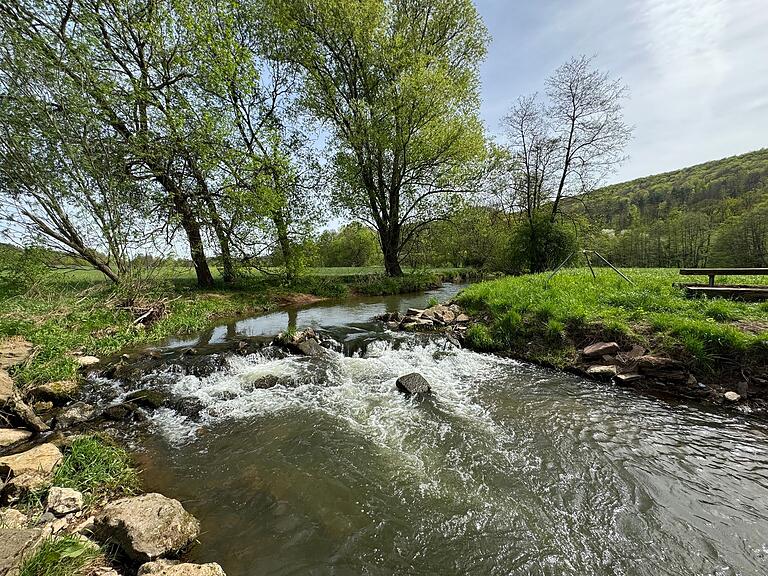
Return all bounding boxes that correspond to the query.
[0,340,224,576]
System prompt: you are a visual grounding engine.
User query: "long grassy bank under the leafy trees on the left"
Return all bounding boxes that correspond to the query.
[0,268,469,387]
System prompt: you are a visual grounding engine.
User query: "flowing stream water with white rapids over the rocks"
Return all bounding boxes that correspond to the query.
[94,287,768,576]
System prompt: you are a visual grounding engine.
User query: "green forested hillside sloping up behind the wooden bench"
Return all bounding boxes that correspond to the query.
[570,149,768,266]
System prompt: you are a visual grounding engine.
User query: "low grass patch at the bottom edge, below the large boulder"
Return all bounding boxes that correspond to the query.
[19,535,102,576]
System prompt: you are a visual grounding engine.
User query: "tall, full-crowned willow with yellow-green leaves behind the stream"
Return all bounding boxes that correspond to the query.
[267,0,488,276]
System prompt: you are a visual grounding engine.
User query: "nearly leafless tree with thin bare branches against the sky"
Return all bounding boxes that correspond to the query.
[495,56,632,272]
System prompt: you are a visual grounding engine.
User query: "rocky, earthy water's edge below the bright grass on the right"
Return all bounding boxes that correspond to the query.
[378,303,768,414]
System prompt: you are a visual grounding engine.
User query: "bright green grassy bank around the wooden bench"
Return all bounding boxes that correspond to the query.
[458,269,768,377]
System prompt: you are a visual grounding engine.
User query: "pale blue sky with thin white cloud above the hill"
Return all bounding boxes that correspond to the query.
[475,0,768,183]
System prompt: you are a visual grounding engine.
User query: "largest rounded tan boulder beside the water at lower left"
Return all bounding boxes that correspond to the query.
[94,493,200,562]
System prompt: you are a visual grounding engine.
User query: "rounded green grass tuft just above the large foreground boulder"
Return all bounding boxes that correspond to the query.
[53,436,139,503]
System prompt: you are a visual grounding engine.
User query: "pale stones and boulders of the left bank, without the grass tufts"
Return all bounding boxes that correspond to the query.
[0,340,224,576]
